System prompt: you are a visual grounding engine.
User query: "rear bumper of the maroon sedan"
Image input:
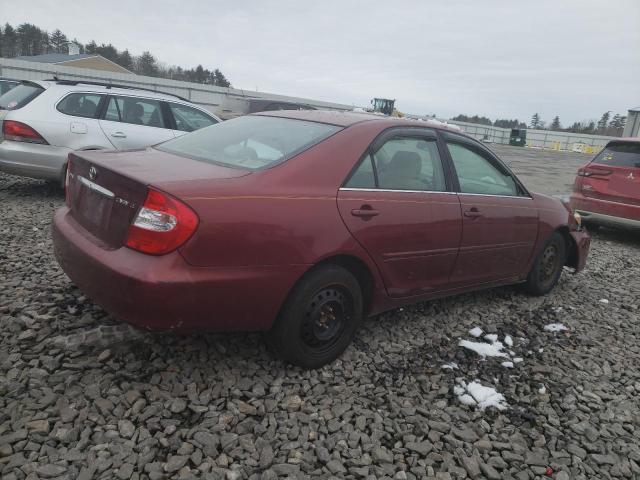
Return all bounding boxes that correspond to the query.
[53,207,308,332]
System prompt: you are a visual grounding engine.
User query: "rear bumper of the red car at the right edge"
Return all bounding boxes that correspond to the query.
[570,193,640,228]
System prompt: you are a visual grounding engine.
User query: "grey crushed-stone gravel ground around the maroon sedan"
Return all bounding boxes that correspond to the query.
[0,147,640,480]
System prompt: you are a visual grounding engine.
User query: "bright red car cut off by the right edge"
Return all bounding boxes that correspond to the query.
[570,138,640,228]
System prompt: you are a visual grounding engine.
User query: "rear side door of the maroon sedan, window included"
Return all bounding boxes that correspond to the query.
[338,128,462,297]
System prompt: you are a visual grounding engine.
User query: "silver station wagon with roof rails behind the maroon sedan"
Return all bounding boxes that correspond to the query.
[0,80,220,183]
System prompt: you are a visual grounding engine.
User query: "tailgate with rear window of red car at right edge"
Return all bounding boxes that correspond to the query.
[578,141,640,205]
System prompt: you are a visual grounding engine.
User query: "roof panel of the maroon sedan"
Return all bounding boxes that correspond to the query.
[251,110,465,135]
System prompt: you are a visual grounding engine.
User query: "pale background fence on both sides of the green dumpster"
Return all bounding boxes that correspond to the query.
[449,120,617,153]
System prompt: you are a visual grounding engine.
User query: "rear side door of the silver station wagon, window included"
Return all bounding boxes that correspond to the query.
[100,95,175,150]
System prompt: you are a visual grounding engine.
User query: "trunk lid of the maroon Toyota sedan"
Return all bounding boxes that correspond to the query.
[66,148,250,249]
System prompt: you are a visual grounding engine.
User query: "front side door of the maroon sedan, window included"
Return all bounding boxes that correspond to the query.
[442,132,538,287]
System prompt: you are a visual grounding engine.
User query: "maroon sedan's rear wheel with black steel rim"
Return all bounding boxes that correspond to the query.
[265,265,363,369]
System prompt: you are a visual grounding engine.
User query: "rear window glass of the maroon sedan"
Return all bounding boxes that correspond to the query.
[156,116,341,170]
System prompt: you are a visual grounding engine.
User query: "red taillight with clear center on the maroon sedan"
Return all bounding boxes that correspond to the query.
[126,188,199,255]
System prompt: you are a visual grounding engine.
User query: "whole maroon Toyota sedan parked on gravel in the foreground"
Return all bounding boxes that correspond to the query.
[53,111,590,368]
